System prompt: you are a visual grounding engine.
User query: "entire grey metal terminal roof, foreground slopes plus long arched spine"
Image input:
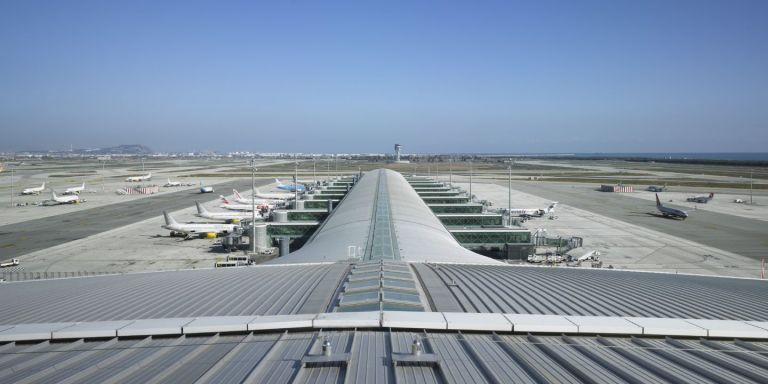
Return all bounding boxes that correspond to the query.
[0,170,768,384]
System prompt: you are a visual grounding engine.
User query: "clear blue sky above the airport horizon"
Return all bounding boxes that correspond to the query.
[0,0,768,152]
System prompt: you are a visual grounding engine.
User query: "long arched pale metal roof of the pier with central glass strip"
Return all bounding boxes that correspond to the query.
[272,169,501,264]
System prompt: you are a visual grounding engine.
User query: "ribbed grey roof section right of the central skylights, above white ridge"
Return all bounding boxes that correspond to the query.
[413,264,768,320]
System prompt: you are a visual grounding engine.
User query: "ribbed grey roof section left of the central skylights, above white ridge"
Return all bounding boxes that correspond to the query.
[0,264,348,324]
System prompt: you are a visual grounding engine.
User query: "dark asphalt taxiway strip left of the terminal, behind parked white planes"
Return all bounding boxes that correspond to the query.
[0,179,272,260]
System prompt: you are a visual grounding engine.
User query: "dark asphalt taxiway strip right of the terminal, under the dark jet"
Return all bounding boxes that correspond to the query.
[494,181,768,260]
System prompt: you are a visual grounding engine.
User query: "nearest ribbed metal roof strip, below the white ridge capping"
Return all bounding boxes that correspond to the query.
[0,330,768,383]
